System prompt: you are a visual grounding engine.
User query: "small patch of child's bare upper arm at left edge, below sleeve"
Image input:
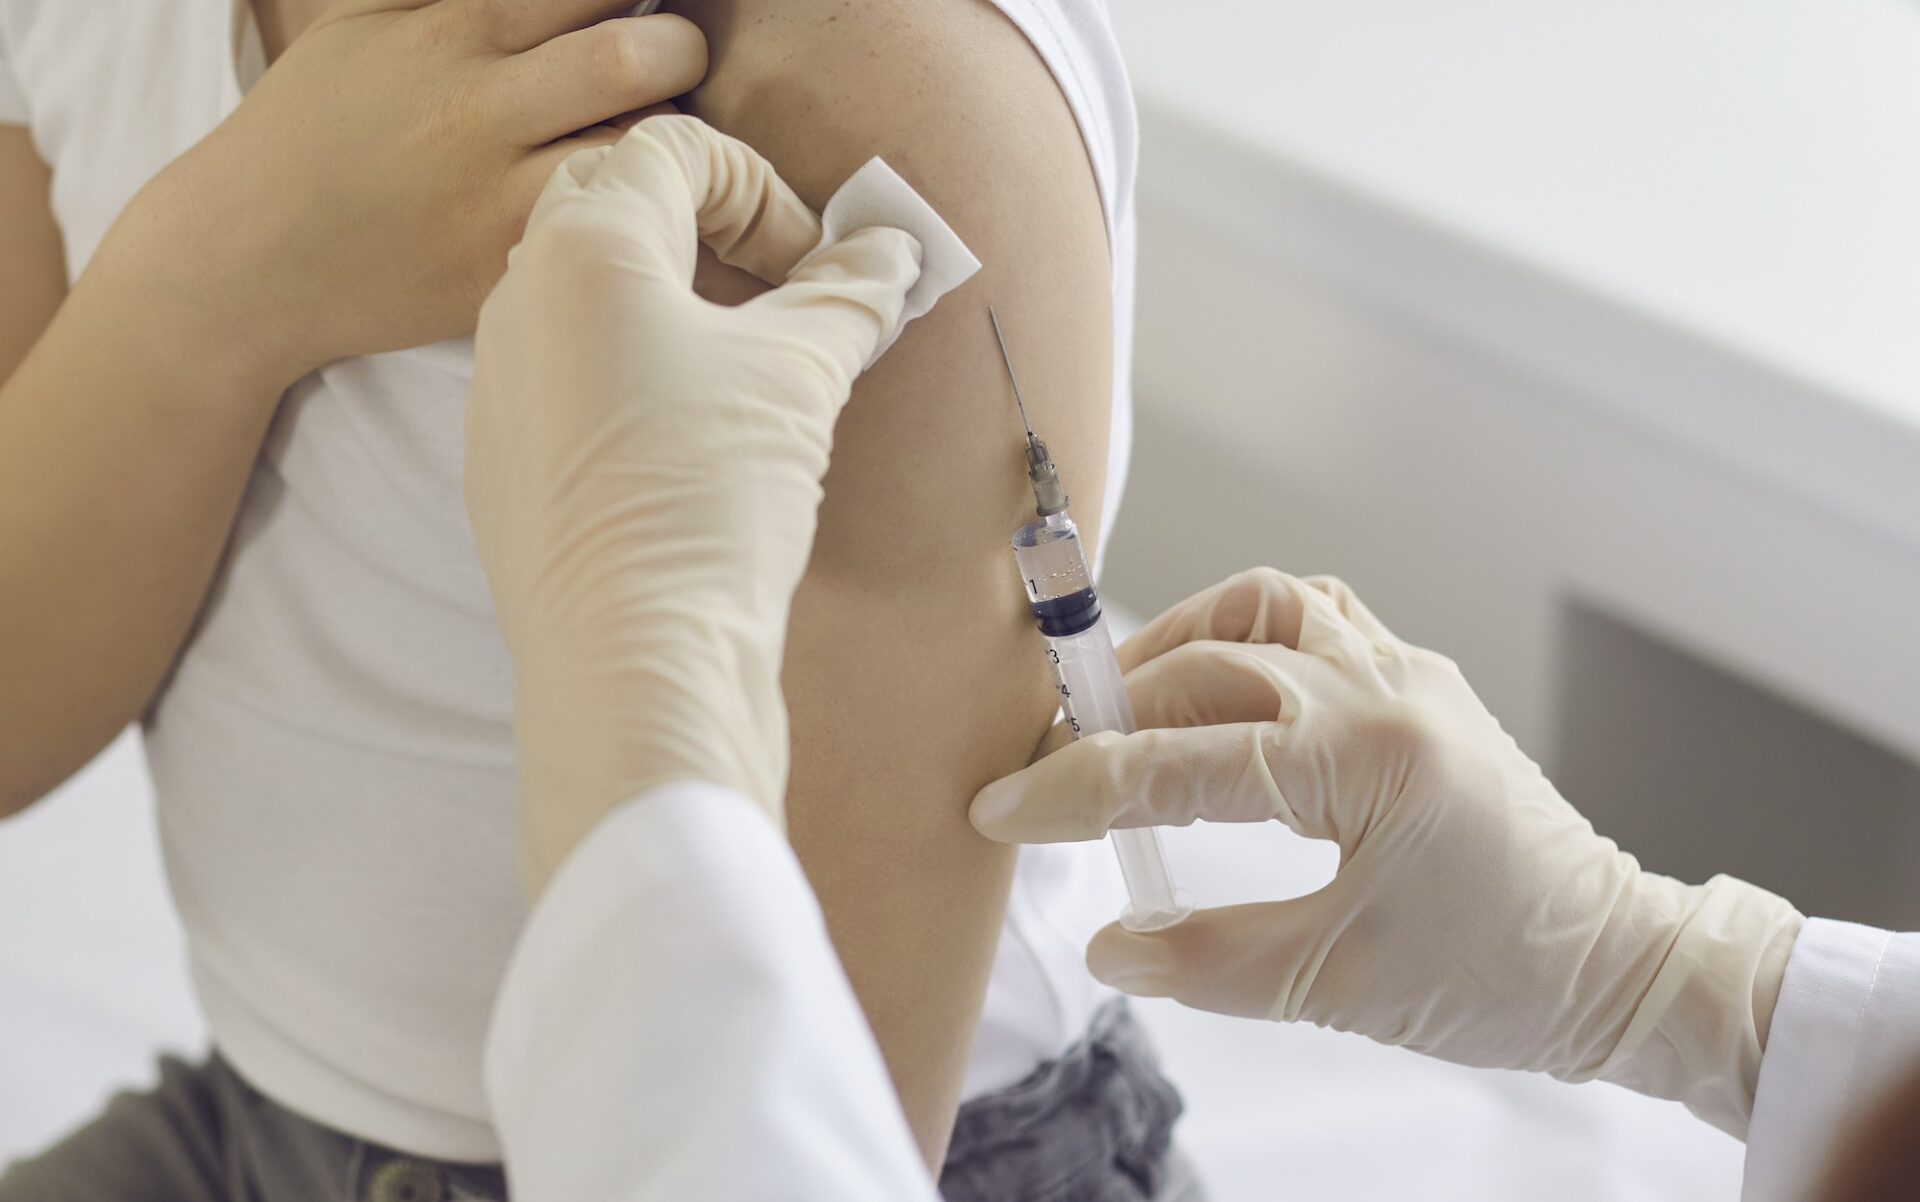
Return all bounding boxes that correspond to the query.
[0,125,67,386]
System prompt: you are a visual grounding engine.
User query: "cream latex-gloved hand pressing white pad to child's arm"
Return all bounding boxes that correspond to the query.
[467,115,920,893]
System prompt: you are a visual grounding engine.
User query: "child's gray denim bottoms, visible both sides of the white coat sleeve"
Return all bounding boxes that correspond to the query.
[0,1004,1202,1202]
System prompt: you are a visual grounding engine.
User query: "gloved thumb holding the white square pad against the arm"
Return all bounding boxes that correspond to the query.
[741,227,920,384]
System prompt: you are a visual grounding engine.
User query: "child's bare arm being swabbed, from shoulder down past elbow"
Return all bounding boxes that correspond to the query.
[682,0,1114,1166]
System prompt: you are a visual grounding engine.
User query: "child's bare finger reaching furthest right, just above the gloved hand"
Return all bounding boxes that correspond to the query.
[493,15,707,146]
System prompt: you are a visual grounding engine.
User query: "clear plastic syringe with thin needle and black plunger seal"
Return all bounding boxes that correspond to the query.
[987,305,1192,931]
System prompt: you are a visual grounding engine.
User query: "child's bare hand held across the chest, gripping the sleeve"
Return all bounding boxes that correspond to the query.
[109,0,707,386]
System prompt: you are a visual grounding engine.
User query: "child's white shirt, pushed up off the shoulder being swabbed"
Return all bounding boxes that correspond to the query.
[0,0,1135,1160]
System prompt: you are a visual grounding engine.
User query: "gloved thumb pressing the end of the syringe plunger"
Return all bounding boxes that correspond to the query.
[1087,893,1334,1020]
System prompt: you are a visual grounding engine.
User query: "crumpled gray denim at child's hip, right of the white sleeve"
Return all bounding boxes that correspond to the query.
[941,1000,1206,1202]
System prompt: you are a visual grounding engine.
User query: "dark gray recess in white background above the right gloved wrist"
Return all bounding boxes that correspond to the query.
[1549,605,1920,931]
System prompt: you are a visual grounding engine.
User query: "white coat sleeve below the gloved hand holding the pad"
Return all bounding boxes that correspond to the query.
[486,783,937,1202]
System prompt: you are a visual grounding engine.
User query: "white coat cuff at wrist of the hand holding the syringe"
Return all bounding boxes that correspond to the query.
[1740,918,1920,1202]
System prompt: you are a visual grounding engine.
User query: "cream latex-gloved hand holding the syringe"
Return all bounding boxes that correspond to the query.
[973,570,1803,1135]
